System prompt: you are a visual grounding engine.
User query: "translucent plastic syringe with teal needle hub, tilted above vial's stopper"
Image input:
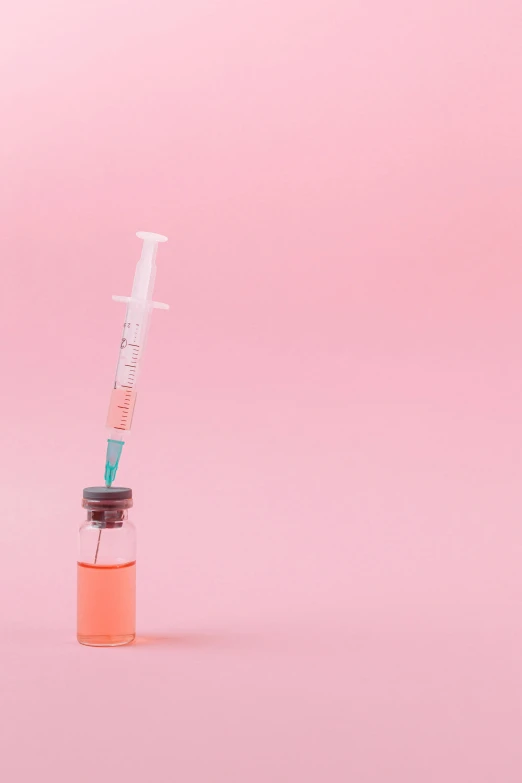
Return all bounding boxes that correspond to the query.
[105,231,169,487]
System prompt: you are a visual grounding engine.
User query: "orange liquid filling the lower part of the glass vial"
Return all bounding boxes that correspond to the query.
[78,561,136,647]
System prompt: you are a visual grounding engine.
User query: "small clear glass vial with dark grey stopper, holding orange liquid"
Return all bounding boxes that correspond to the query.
[77,487,136,647]
